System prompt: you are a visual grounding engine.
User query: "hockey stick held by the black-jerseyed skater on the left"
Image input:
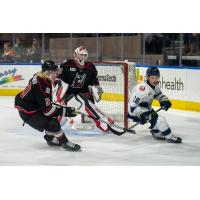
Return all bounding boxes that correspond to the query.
[53,102,135,136]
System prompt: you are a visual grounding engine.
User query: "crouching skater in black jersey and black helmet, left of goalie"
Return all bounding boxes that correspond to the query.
[15,61,81,151]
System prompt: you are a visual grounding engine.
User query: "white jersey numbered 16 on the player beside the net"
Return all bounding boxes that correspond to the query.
[128,80,168,117]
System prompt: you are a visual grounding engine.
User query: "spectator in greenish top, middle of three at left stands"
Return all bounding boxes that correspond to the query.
[12,37,25,62]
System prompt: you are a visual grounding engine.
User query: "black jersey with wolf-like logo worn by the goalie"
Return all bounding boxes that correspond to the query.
[58,59,99,101]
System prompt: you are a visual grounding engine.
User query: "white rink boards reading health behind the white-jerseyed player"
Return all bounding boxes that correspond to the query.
[136,66,200,112]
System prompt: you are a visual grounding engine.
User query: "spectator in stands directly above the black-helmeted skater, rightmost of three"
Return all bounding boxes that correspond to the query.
[27,38,41,63]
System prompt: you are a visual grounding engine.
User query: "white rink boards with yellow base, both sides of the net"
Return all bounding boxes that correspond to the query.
[0,64,200,112]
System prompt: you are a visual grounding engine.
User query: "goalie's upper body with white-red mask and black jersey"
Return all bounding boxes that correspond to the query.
[59,46,103,103]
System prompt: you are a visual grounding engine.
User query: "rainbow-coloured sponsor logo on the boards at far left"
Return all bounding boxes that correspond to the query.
[0,68,24,85]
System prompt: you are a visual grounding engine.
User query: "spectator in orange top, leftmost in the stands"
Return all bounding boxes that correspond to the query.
[1,42,15,63]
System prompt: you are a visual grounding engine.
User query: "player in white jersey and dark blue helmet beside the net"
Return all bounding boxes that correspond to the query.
[128,67,182,143]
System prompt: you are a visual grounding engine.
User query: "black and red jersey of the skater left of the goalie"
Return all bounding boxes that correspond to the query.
[15,75,62,117]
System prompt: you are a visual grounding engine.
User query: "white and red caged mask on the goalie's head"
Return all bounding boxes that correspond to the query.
[74,46,88,65]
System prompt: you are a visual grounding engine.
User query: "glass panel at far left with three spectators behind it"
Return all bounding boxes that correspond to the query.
[0,33,42,63]
